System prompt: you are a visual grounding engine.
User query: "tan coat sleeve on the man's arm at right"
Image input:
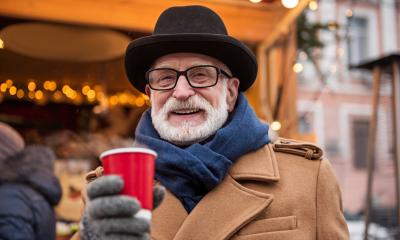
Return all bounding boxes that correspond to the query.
[316,159,349,240]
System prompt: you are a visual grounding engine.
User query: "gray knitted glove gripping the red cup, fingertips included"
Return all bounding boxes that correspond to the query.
[81,175,165,240]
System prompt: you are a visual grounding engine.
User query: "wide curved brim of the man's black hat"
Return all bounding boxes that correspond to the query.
[125,33,257,93]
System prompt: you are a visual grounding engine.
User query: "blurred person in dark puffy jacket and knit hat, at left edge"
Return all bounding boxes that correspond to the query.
[0,122,61,240]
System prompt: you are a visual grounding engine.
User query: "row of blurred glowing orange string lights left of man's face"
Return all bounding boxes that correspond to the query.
[0,79,150,108]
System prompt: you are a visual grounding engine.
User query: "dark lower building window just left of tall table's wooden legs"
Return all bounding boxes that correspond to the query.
[353,119,370,169]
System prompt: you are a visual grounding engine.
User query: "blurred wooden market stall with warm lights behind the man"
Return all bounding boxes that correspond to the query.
[0,0,310,238]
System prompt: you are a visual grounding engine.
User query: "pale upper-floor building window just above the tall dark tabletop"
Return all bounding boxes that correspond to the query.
[347,16,369,65]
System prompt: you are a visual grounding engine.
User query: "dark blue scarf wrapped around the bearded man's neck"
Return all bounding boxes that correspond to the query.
[135,93,269,212]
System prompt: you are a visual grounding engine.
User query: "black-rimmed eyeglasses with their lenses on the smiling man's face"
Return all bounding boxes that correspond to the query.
[146,65,232,90]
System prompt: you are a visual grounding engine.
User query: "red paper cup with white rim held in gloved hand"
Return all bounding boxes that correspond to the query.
[100,148,157,219]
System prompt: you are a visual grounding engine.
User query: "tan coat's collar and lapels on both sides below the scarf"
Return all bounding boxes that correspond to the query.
[152,144,279,240]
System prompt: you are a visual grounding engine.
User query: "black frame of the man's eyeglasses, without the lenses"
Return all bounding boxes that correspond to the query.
[146,65,233,91]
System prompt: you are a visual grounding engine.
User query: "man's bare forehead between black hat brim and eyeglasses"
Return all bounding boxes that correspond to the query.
[152,53,226,68]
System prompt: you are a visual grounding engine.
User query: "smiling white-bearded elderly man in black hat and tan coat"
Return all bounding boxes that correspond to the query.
[77,6,348,240]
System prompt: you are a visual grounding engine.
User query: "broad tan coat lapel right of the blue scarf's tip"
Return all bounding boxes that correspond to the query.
[174,175,272,240]
